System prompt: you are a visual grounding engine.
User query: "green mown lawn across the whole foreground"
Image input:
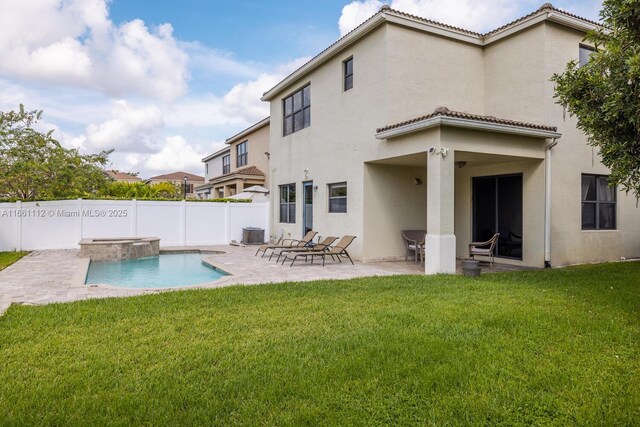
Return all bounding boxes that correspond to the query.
[0,263,640,425]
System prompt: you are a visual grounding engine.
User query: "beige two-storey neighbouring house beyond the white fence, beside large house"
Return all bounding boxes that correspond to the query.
[196,117,269,199]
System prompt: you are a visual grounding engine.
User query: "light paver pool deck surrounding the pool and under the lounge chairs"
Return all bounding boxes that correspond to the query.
[0,246,536,314]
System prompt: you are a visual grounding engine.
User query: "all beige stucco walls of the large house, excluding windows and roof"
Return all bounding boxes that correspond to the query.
[265,18,640,266]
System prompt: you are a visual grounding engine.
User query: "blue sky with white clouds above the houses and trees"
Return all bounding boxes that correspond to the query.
[0,0,602,178]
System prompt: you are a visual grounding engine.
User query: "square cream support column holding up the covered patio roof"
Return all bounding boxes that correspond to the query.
[424,147,456,274]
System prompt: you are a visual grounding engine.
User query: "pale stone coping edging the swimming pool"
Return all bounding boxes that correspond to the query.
[69,248,235,292]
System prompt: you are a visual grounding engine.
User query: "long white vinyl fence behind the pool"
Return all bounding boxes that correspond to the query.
[0,199,269,251]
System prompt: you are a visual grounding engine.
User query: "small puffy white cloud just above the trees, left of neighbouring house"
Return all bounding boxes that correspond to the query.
[144,135,206,172]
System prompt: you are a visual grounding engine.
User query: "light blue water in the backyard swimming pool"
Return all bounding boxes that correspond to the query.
[85,253,226,288]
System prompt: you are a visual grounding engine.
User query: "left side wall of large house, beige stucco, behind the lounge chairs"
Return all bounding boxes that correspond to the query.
[270,27,388,254]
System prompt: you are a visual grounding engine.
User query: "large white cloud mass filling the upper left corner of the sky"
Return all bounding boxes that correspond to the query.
[0,0,188,100]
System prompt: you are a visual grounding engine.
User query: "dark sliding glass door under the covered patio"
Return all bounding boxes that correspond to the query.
[473,174,522,259]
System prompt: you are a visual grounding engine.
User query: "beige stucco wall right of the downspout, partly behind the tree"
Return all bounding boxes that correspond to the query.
[545,24,640,265]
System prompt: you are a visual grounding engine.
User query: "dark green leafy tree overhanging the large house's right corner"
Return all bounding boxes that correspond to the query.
[552,0,640,198]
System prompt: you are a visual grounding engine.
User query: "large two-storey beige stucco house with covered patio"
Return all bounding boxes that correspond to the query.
[262,4,640,273]
